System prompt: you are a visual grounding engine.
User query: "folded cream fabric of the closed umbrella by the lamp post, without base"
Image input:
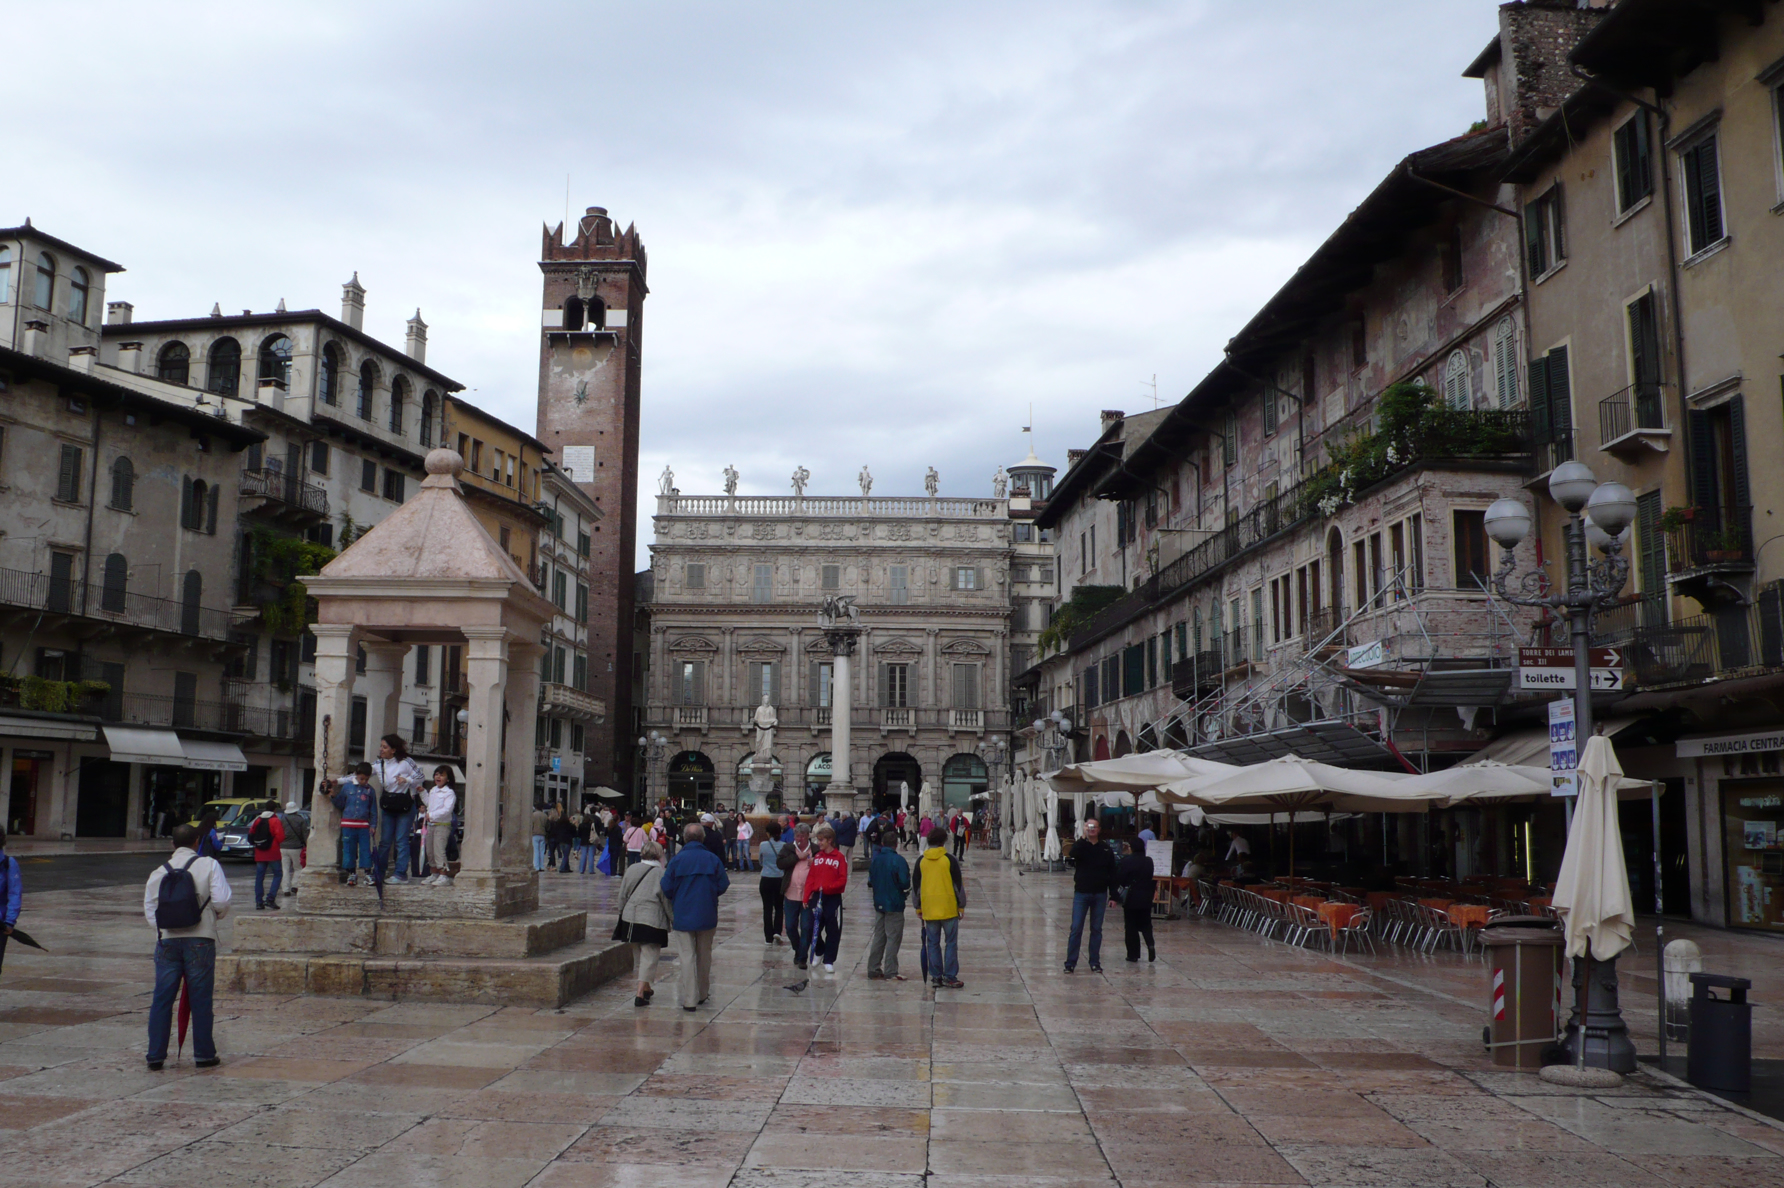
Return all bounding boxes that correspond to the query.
[1554,735,1636,961]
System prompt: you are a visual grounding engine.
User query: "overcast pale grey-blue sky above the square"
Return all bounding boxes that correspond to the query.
[0,0,1497,564]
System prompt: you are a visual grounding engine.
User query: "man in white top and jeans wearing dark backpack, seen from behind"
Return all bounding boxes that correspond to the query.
[143,824,230,1072]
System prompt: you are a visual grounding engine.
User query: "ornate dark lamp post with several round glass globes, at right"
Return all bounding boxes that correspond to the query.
[1486,462,1636,1072]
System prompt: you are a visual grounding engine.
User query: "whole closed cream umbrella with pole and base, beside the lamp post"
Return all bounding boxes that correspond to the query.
[1543,735,1636,1085]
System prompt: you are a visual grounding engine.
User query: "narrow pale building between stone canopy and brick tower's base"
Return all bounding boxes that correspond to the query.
[535,454,617,812]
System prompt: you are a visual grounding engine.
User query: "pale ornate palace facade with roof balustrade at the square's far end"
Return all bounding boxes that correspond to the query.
[640,467,1020,808]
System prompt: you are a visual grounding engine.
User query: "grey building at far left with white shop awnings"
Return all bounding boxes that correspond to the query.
[0,225,266,838]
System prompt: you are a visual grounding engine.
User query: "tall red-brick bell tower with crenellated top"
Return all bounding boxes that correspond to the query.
[537,207,649,792]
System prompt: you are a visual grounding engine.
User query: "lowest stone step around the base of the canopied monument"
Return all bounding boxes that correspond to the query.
[216,940,632,1006]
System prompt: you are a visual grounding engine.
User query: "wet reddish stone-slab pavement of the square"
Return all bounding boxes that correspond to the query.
[0,851,1784,1188]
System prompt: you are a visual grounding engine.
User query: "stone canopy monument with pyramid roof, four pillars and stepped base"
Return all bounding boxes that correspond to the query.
[218,450,628,1006]
